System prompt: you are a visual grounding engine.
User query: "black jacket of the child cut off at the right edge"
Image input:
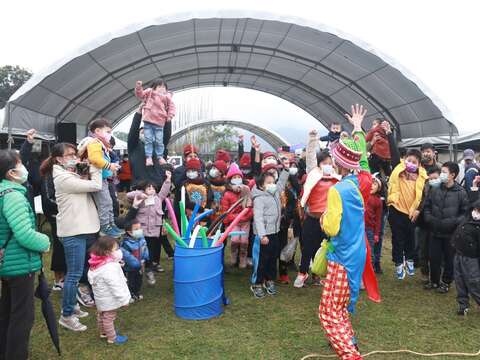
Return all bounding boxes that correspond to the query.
[452,215,480,258]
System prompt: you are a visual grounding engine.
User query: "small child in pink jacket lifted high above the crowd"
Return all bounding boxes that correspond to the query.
[135,80,175,166]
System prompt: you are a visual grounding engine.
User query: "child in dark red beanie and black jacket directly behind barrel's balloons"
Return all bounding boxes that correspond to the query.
[175,157,213,217]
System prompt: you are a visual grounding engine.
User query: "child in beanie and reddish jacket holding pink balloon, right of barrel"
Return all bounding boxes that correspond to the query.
[220,163,253,269]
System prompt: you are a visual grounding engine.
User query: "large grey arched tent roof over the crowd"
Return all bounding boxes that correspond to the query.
[6,11,457,138]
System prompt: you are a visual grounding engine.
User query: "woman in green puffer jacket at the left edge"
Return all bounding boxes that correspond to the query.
[0,150,50,359]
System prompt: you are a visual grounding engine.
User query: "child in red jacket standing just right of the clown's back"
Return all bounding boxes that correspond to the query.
[365,176,383,274]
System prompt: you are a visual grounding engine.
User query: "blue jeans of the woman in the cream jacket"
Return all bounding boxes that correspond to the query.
[61,234,93,316]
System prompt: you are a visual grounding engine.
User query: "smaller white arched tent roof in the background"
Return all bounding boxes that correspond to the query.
[170,119,290,149]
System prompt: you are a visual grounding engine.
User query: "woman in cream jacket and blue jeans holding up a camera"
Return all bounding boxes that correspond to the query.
[47,143,102,331]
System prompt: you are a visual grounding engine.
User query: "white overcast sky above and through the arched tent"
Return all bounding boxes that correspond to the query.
[0,0,480,142]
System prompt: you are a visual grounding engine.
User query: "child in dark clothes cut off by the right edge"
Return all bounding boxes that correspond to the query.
[453,201,480,316]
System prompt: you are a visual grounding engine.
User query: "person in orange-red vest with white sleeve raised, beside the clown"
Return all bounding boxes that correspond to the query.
[293,130,340,288]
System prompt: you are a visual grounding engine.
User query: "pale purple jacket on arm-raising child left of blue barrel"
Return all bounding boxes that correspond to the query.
[127,180,172,237]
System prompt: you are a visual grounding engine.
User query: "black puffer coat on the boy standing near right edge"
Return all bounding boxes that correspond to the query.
[424,183,469,238]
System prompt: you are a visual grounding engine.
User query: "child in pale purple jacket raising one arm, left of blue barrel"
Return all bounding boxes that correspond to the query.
[127,171,172,285]
